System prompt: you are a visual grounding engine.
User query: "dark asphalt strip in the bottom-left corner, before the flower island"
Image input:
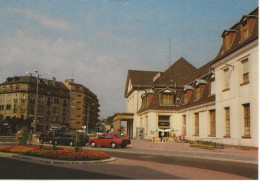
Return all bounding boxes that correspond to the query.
[0,157,127,180]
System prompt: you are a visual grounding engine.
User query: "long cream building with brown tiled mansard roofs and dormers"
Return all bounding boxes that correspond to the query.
[113,8,259,147]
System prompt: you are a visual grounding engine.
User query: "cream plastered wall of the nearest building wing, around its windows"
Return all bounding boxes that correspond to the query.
[215,40,259,147]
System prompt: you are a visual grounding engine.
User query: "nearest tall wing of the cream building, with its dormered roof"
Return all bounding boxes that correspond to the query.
[212,8,259,147]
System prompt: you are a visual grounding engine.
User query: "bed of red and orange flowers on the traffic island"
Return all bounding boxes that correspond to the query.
[0,146,109,161]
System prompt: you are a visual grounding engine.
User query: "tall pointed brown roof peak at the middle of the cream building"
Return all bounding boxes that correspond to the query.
[154,57,197,87]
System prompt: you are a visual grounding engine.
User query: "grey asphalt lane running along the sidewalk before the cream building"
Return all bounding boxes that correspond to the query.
[89,148,258,179]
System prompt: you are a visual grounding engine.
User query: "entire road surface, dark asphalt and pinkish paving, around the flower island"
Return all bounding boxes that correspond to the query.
[0,137,258,180]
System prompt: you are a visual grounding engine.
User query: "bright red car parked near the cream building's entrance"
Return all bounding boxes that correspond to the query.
[88,133,131,148]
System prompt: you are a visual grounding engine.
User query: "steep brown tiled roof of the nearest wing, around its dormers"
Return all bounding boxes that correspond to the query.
[211,7,258,64]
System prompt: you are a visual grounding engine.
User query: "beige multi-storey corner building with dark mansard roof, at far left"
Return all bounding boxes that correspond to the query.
[0,75,69,131]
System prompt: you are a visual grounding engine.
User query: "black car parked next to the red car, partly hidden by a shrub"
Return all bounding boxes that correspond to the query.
[54,133,89,146]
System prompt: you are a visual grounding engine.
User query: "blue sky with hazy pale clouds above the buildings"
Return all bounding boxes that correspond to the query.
[0,0,258,119]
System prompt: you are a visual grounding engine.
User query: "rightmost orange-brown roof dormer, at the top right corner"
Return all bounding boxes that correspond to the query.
[239,15,257,41]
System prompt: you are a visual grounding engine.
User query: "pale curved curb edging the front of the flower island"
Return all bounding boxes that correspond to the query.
[10,155,117,164]
